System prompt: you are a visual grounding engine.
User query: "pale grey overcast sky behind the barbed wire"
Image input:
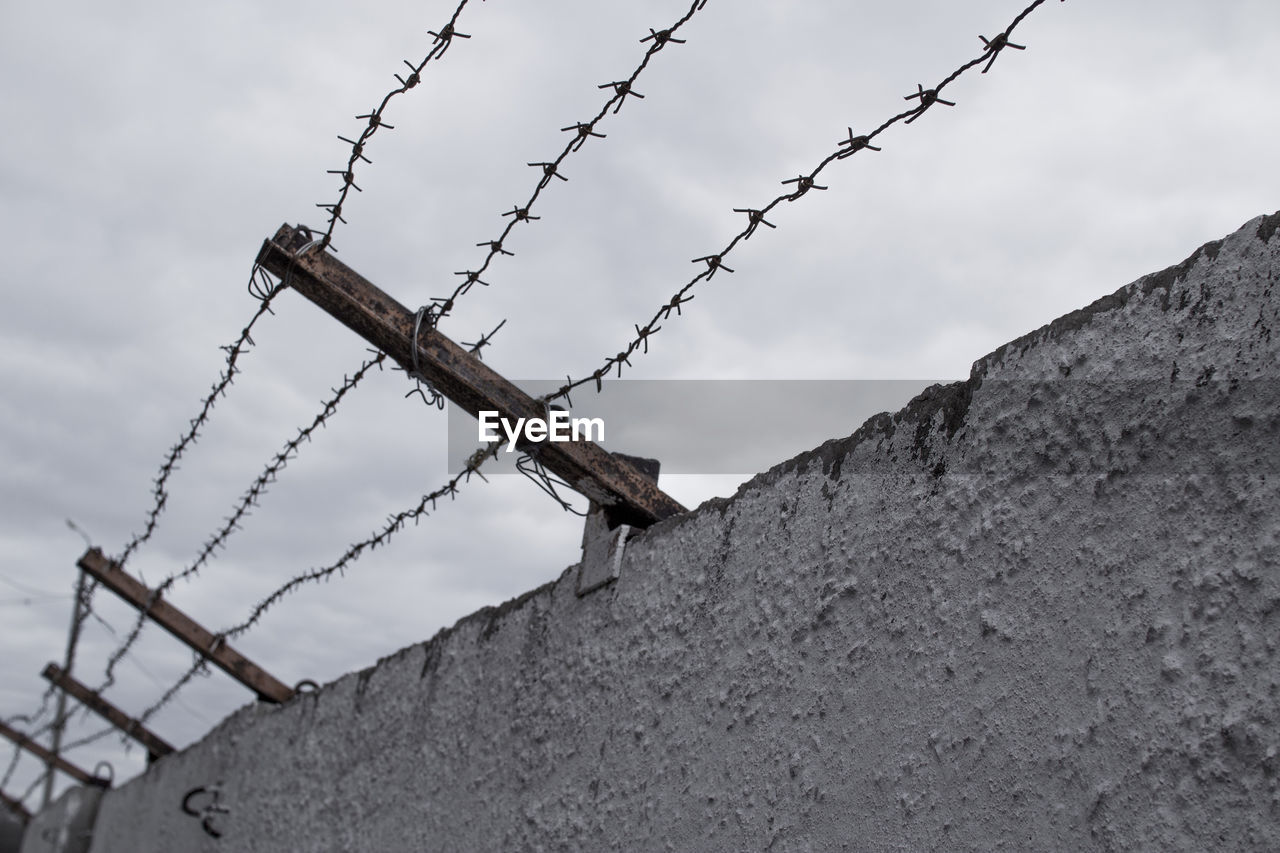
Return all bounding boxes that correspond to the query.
[0,0,1280,806]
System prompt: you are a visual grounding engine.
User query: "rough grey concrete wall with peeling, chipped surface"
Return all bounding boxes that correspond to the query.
[82,208,1280,853]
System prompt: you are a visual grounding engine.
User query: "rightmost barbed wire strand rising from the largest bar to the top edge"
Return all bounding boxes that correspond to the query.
[540,0,1046,403]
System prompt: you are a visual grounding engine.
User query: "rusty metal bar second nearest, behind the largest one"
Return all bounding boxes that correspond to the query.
[76,548,293,702]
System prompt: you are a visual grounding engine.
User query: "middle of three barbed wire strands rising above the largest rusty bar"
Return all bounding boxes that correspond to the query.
[414,0,707,327]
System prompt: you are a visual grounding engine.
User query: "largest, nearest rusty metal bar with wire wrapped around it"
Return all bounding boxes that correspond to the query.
[257,225,685,528]
